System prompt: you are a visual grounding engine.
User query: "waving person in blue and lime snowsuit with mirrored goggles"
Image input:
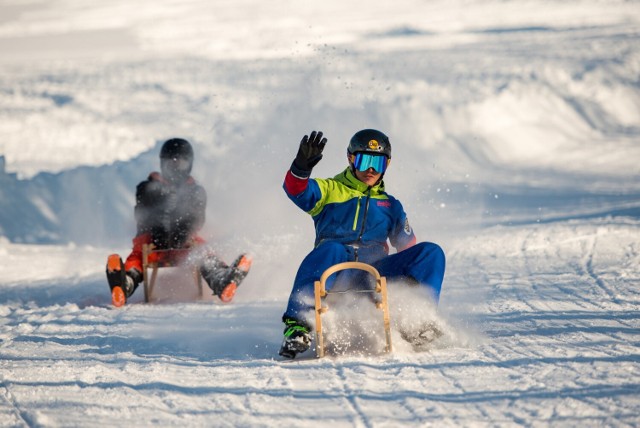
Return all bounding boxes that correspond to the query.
[280,129,445,358]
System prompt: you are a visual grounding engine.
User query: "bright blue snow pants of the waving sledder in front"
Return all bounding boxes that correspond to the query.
[284,241,445,324]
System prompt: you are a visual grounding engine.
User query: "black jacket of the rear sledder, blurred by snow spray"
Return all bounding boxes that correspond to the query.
[134,172,207,249]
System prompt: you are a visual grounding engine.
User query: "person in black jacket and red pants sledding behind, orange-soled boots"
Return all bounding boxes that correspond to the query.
[107,138,251,307]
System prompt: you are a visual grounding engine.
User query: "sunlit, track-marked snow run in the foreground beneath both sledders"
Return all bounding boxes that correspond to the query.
[0,218,640,426]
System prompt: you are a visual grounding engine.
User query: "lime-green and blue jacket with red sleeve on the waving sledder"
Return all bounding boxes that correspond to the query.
[283,168,416,254]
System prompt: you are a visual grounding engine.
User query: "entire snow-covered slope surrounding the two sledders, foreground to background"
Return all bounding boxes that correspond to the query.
[0,0,640,427]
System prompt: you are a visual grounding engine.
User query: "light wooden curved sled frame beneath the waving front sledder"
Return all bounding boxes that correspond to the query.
[314,262,392,358]
